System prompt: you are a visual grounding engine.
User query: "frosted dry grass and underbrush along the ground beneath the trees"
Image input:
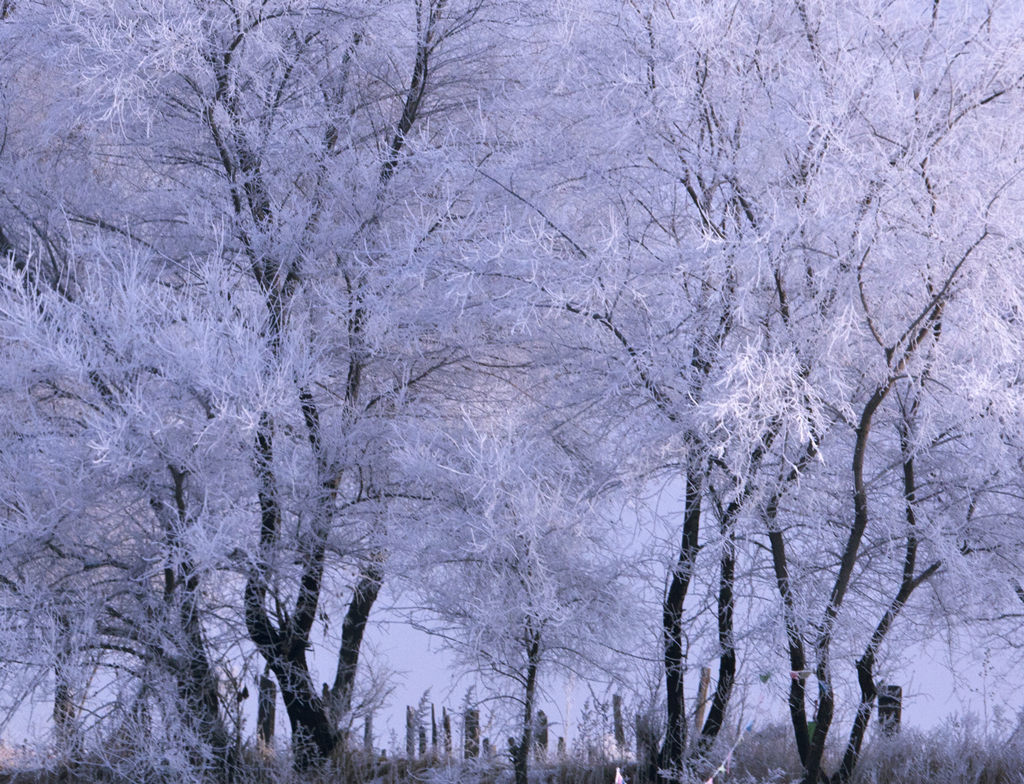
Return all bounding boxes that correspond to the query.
[6,720,1024,784]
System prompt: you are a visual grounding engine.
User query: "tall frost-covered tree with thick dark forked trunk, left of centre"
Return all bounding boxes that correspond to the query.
[3,0,540,766]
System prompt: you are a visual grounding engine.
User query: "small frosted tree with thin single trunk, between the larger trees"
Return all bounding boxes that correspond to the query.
[397,421,631,784]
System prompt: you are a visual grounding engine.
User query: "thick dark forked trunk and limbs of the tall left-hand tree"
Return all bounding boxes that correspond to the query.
[214,9,445,770]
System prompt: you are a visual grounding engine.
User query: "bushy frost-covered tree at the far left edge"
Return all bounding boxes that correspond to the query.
[0,247,251,775]
